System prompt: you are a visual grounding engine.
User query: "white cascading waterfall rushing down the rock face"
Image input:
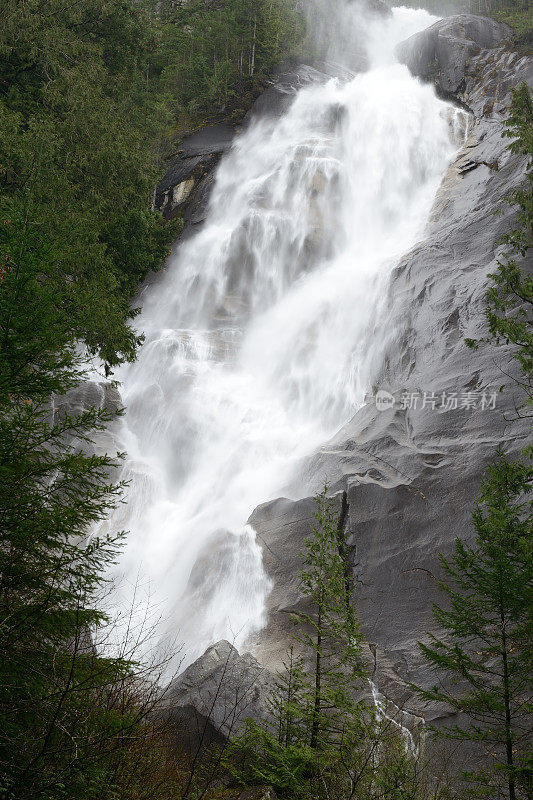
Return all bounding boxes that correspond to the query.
[103,9,464,663]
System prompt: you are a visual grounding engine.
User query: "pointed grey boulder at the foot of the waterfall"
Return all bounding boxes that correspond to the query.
[165,641,274,737]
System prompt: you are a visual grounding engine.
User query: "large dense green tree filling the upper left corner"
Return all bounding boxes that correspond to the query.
[0,0,175,369]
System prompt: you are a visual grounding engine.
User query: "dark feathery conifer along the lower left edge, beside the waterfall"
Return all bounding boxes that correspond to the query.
[0,266,174,800]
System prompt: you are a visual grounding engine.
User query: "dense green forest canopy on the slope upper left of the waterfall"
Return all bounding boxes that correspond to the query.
[0,0,302,380]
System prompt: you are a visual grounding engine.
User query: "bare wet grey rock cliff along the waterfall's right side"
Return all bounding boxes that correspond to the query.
[166,15,533,736]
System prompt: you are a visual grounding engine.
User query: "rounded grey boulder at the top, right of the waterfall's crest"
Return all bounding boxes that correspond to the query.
[396,14,512,95]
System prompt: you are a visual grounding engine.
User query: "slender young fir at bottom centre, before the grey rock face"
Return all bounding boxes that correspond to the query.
[224,490,428,800]
